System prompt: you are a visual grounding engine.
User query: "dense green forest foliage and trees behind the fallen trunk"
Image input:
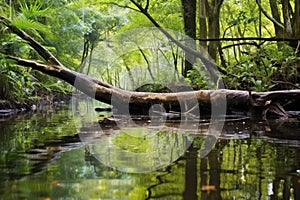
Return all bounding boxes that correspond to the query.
[0,0,300,106]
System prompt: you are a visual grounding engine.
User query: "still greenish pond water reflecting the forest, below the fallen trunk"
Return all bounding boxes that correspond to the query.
[0,105,300,200]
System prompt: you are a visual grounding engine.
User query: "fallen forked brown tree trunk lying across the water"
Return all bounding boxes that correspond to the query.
[0,16,300,118]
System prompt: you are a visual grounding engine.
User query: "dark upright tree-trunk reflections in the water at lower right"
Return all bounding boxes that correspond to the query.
[143,129,300,200]
